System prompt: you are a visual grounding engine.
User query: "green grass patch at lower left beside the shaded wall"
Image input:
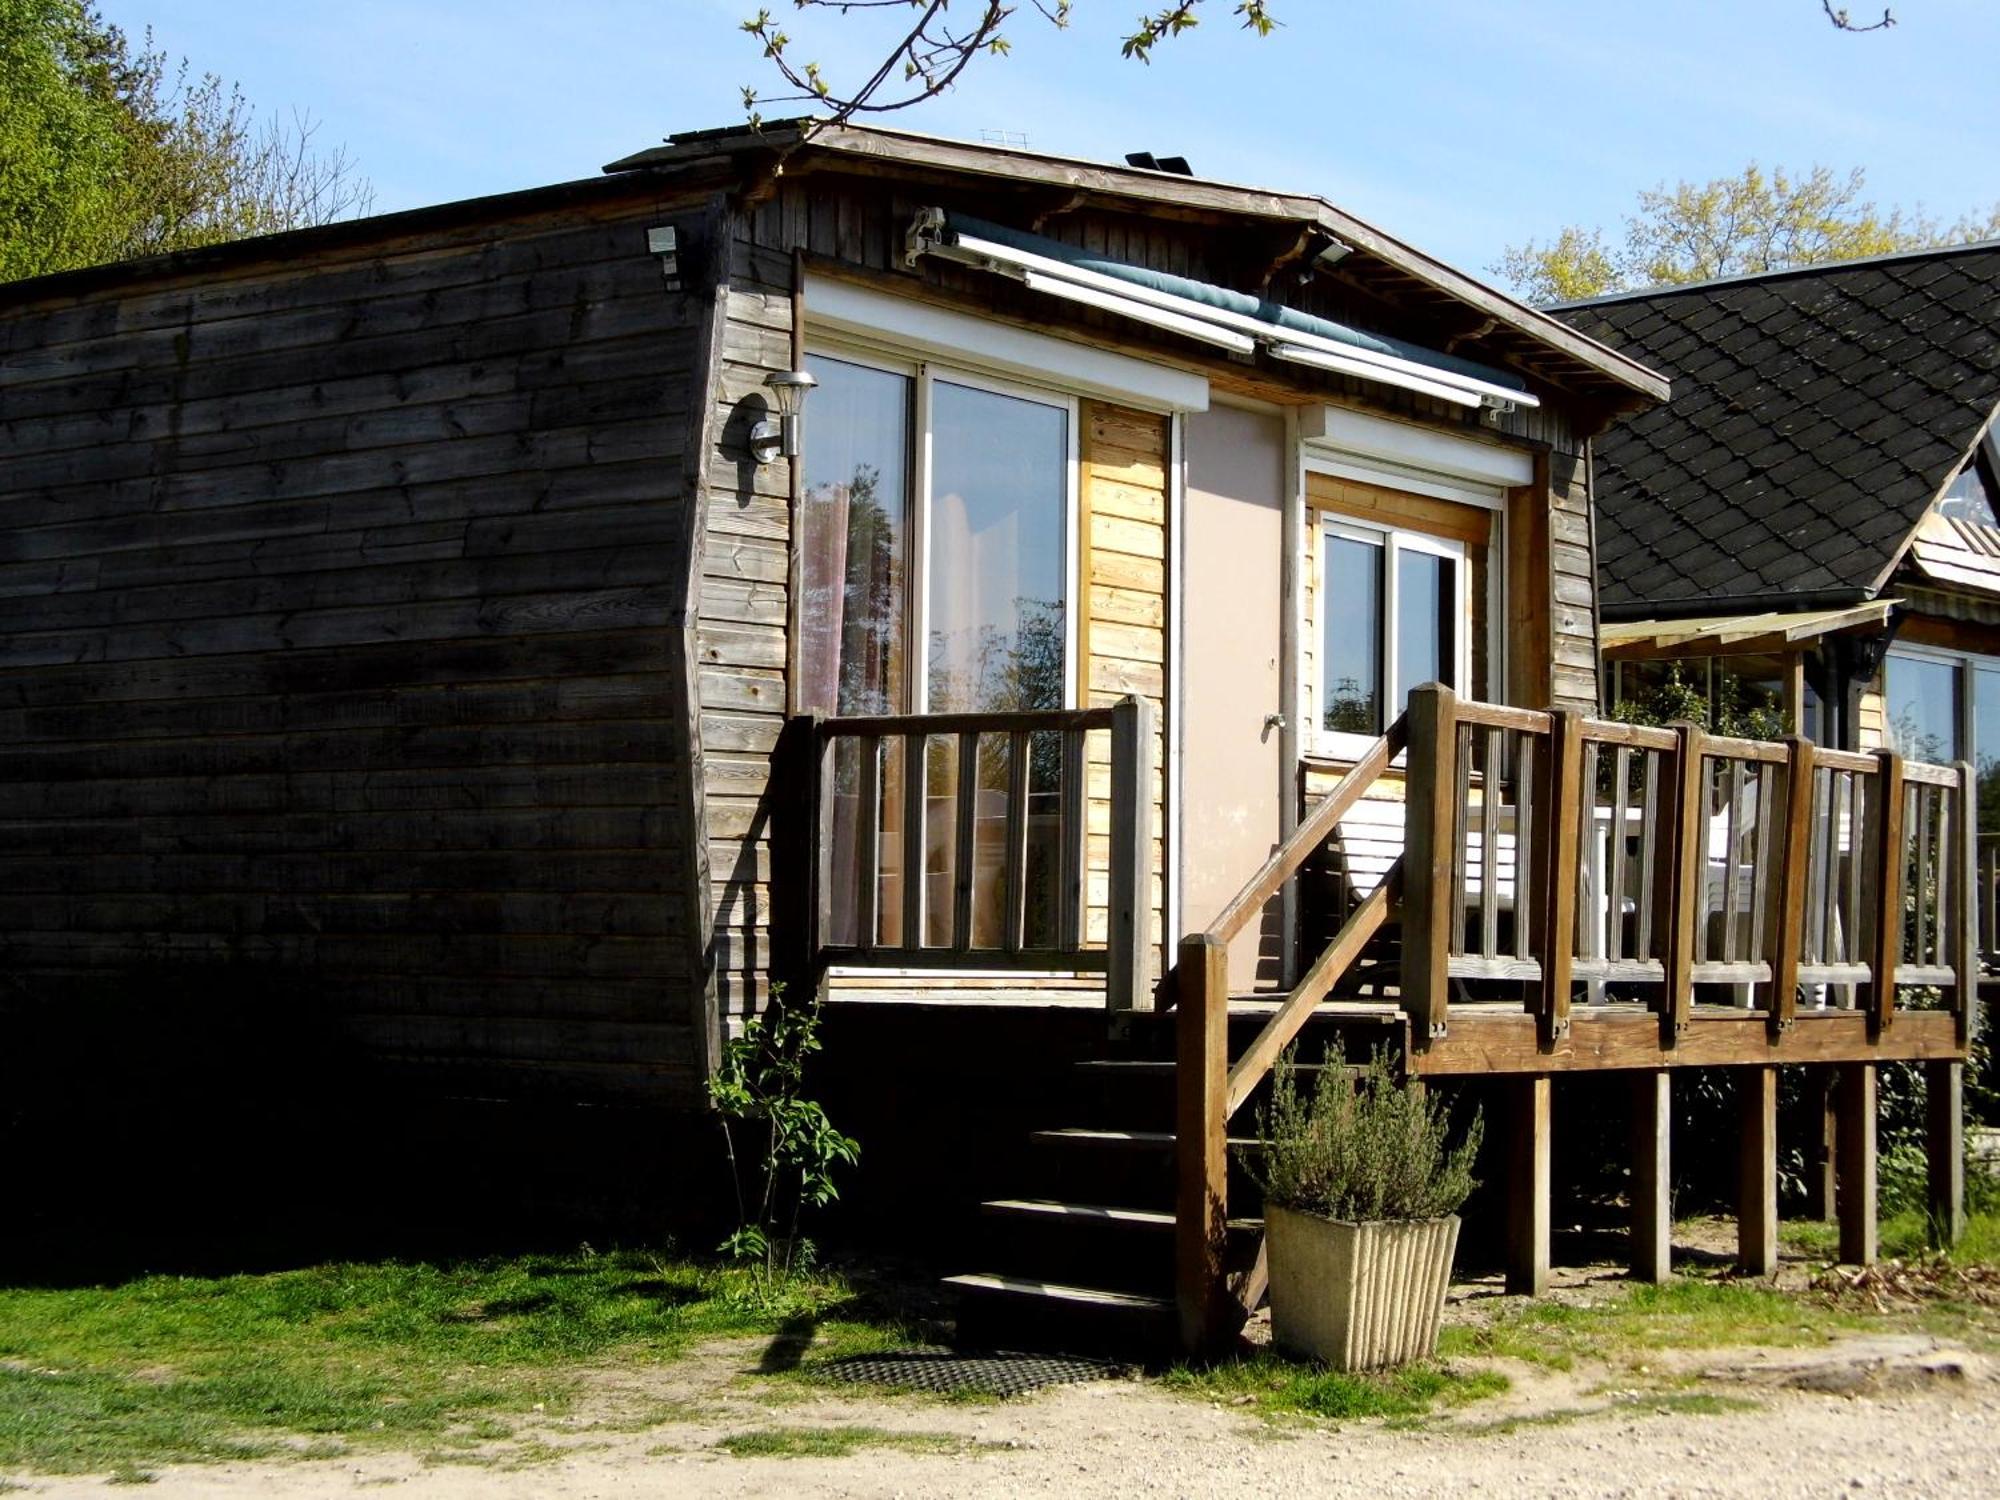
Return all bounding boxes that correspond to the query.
[0,1252,884,1474]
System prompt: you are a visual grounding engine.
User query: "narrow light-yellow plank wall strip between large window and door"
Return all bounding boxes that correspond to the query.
[1078,400,1170,980]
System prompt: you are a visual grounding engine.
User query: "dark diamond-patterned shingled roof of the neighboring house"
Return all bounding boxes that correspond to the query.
[1550,240,2000,618]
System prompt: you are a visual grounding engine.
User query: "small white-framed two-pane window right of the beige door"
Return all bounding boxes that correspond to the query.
[1318,516,1472,754]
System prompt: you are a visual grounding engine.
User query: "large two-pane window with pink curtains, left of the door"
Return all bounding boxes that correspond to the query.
[800,350,1076,948]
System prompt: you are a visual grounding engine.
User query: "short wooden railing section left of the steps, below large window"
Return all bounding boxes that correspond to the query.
[812,698,1154,1010]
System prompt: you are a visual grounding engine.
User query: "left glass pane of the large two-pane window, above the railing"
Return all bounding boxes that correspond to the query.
[800,356,910,714]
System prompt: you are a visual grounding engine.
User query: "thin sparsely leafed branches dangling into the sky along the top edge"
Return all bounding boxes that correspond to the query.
[742,0,1896,128]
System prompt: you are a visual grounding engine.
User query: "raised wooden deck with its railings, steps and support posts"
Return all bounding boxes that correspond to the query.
[810,684,1980,1350]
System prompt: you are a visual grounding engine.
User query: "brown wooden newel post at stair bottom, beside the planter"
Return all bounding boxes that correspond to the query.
[1174,934,1232,1354]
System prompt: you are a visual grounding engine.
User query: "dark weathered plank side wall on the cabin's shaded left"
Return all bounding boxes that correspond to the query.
[0,191,716,1104]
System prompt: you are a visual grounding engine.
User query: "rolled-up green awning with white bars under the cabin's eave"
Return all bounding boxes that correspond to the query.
[910,208,1540,408]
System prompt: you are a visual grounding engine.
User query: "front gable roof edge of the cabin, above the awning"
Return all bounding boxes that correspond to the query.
[604,120,1668,414]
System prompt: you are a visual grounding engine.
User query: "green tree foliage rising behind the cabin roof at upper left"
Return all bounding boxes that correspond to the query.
[0,0,374,280]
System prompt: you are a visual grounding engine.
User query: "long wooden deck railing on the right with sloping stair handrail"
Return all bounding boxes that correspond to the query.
[1176,684,1976,1348]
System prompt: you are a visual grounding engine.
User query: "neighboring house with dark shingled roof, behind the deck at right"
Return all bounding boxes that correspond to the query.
[1554,242,2000,950]
